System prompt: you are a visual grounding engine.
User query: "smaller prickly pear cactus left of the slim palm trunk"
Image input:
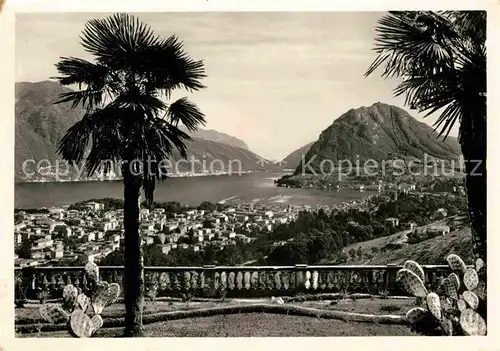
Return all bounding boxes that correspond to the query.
[40,263,120,338]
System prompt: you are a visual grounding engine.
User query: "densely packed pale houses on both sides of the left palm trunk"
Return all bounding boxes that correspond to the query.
[15,201,302,267]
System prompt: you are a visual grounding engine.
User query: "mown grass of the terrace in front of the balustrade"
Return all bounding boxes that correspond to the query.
[15,299,415,337]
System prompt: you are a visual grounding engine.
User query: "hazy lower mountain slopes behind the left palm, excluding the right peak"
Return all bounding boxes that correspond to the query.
[15,81,276,181]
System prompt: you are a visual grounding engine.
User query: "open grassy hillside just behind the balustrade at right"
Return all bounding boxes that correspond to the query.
[344,228,473,264]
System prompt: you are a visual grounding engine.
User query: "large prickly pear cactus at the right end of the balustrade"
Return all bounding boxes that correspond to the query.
[397,254,486,336]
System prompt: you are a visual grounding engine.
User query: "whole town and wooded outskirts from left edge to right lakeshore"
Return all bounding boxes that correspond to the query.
[15,180,463,267]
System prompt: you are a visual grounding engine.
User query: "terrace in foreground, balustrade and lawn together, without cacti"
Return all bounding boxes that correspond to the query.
[15,265,458,337]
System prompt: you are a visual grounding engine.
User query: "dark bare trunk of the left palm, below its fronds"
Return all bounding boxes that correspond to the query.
[122,164,144,337]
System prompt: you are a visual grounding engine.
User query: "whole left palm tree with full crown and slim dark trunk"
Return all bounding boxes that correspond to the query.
[54,14,205,336]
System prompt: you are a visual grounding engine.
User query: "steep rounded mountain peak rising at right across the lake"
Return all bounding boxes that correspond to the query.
[295,102,460,174]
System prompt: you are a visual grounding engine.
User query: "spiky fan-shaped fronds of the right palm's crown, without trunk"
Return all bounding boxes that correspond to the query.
[365,11,486,138]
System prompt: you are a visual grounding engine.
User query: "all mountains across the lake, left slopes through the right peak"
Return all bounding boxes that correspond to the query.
[15,81,460,181]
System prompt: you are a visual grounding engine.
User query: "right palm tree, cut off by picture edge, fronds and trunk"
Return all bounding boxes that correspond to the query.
[365,11,486,262]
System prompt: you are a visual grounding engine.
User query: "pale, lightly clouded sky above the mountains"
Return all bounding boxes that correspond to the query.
[16,12,457,160]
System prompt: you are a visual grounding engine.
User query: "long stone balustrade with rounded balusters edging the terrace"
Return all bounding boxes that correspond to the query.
[15,265,450,300]
